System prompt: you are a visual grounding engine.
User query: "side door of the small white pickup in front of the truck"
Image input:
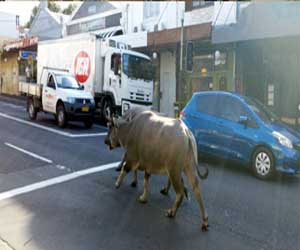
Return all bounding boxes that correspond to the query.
[42,74,56,113]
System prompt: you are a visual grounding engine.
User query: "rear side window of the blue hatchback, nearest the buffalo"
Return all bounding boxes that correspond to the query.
[197,95,218,116]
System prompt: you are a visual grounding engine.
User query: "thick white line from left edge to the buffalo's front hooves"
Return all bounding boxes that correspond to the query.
[0,162,120,201]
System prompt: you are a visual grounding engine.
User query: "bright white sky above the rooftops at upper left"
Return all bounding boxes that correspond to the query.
[0,0,81,25]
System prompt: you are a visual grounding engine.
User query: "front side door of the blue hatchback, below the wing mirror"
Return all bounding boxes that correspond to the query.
[214,95,258,161]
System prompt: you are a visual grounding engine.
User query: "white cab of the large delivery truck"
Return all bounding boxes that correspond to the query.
[101,41,154,121]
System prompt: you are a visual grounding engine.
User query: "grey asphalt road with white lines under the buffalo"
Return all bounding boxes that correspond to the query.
[0,96,300,250]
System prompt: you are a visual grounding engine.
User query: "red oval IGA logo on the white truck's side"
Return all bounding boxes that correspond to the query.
[74,51,91,83]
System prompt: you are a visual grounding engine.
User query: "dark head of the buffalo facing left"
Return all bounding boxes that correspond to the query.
[104,117,121,150]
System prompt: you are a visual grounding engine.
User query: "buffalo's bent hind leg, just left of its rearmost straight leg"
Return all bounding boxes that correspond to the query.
[166,173,184,218]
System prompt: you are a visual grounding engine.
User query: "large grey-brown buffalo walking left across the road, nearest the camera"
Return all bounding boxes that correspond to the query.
[105,111,208,231]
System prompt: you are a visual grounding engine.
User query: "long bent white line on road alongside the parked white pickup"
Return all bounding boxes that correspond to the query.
[0,113,107,138]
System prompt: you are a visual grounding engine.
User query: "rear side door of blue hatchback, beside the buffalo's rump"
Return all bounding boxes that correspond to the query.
[187,94,224,154]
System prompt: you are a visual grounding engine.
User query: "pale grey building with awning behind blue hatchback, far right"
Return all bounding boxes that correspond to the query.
[212,2,300,124]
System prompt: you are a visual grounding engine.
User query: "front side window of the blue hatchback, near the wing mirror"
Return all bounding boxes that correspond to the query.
[218,96,250,122]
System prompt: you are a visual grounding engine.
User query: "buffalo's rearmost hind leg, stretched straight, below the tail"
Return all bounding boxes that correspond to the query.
[184,165,209,231]
